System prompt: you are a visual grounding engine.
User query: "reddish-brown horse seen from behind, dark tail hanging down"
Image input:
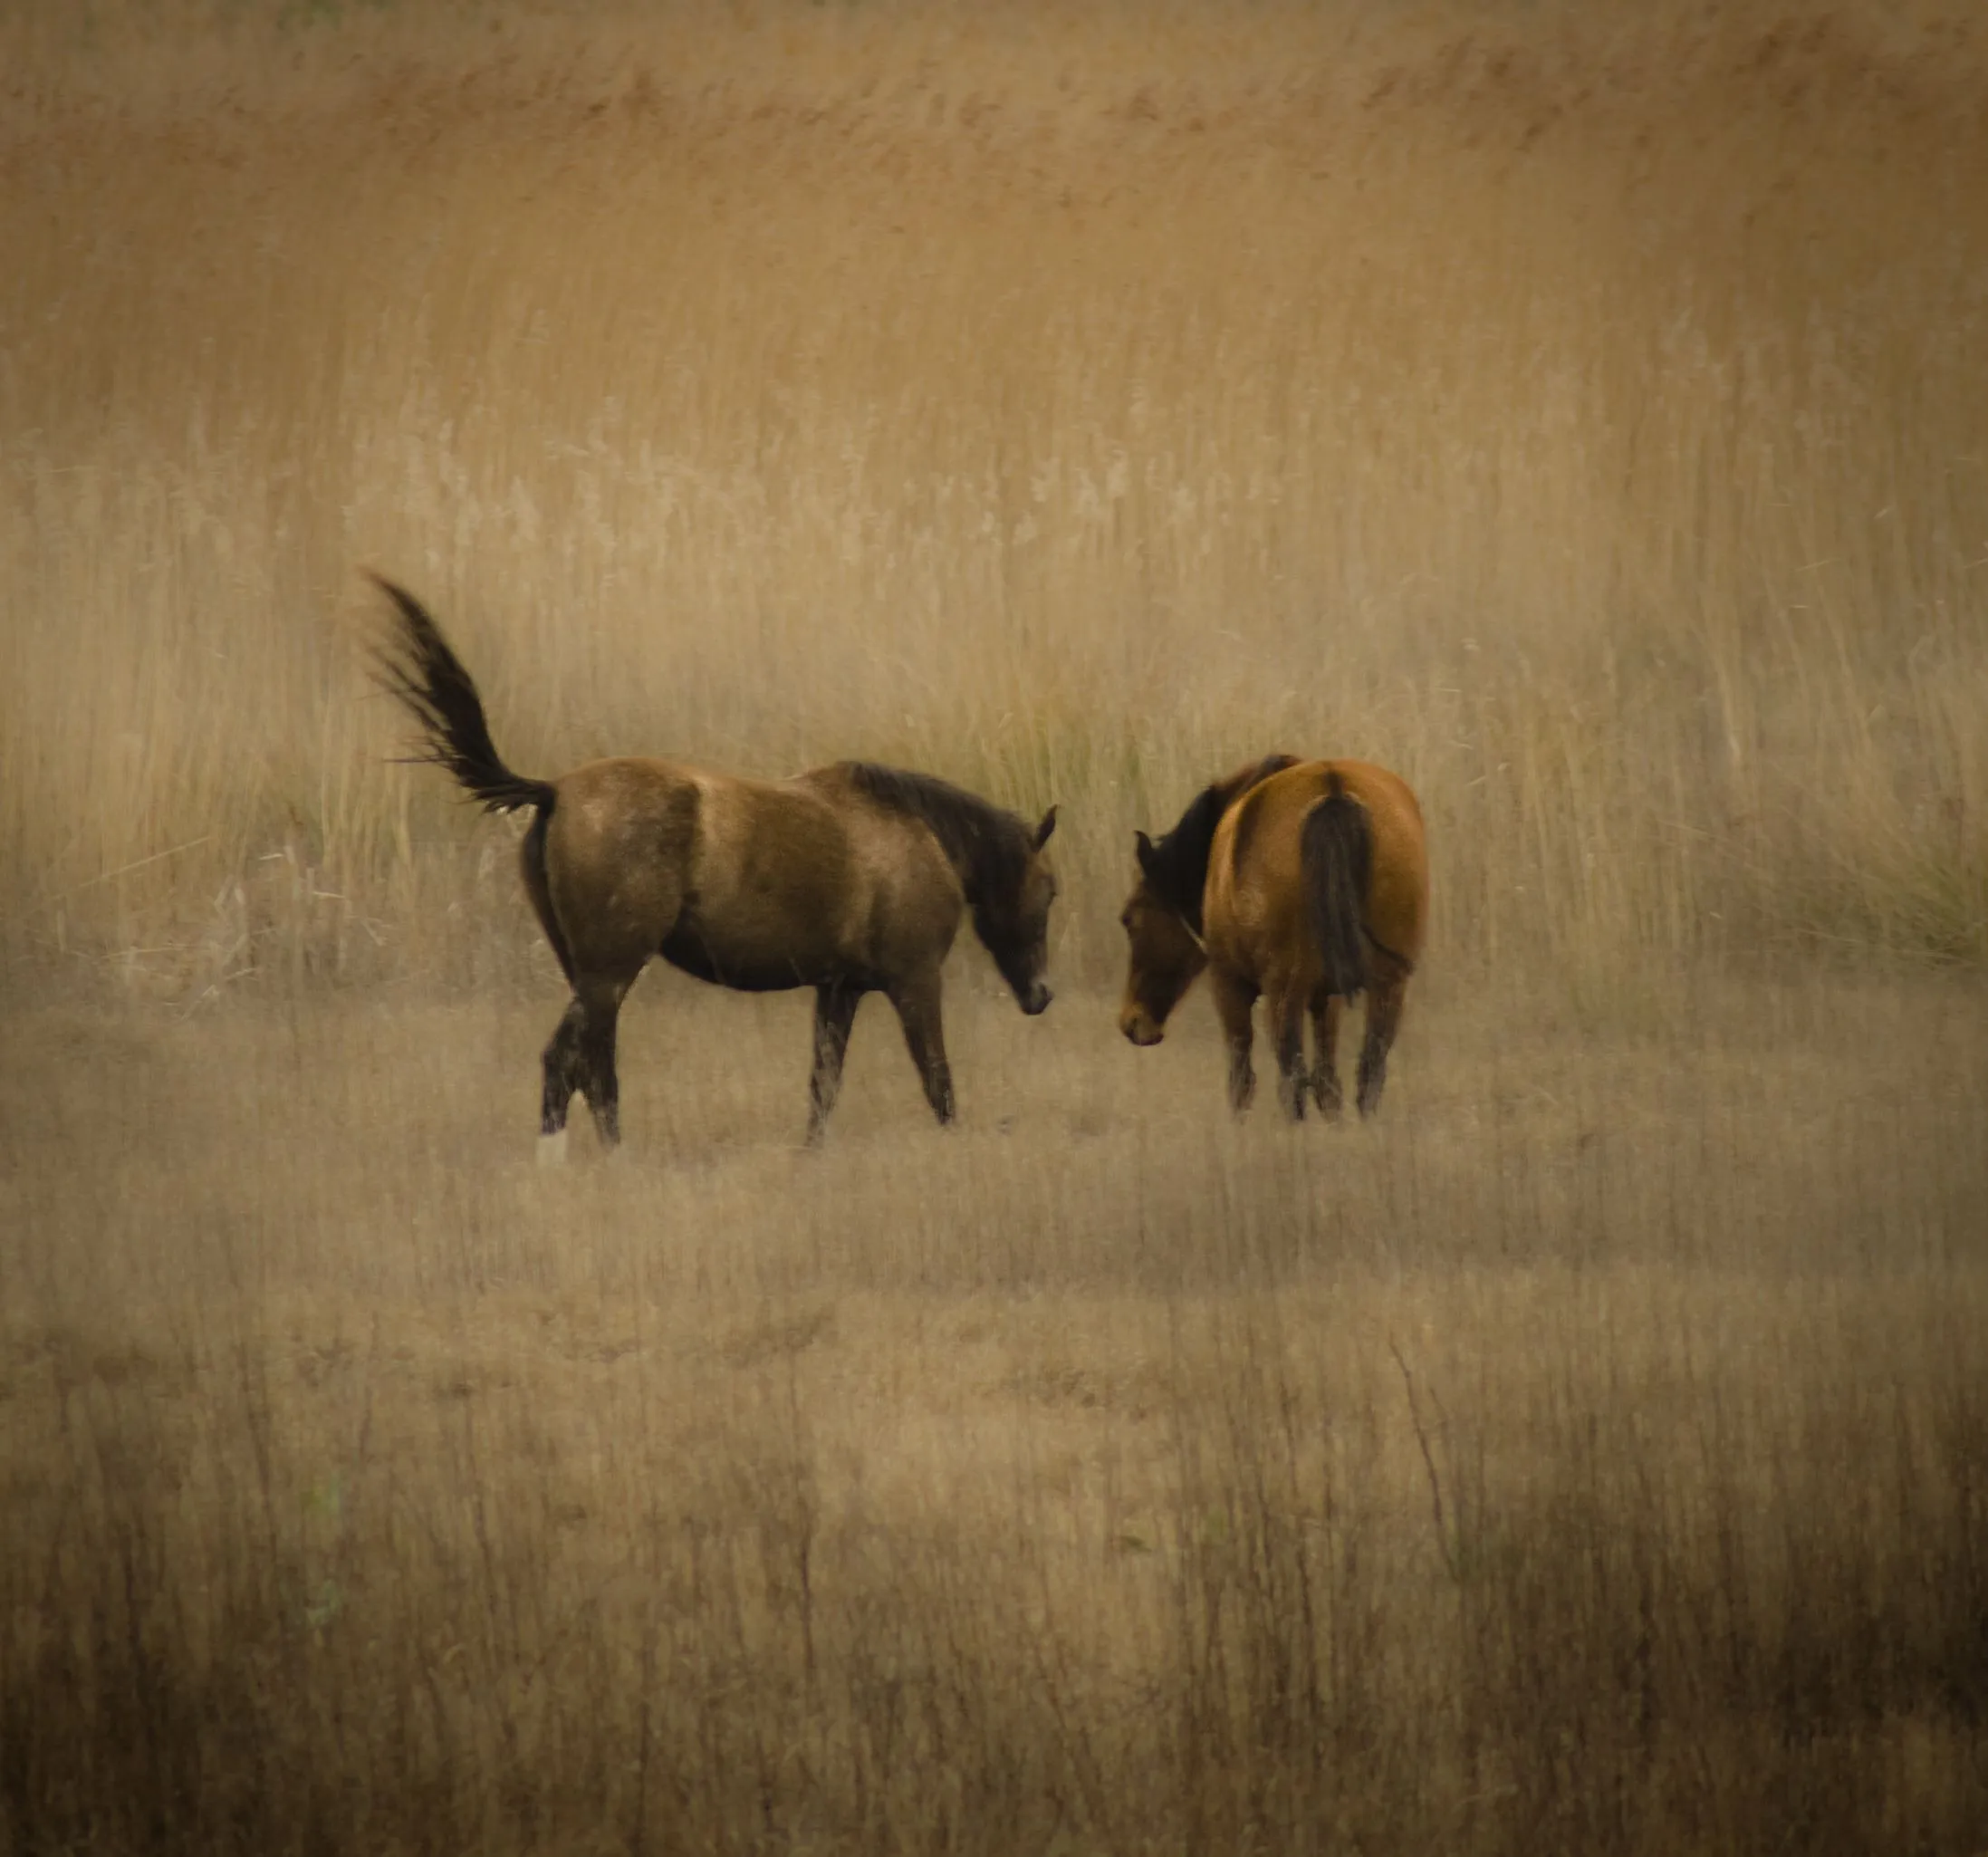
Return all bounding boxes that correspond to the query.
[1119,754,1429,1121]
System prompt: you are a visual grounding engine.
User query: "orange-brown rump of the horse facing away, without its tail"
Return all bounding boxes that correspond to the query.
[1206,759,1429,970]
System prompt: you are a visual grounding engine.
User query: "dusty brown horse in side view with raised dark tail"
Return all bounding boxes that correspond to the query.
[376,577,1056,1157]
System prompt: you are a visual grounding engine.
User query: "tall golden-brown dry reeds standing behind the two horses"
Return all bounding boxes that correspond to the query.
[0,6,1988,994]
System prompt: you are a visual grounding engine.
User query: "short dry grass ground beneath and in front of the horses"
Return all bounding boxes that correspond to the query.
[0,982,1988,1851]
